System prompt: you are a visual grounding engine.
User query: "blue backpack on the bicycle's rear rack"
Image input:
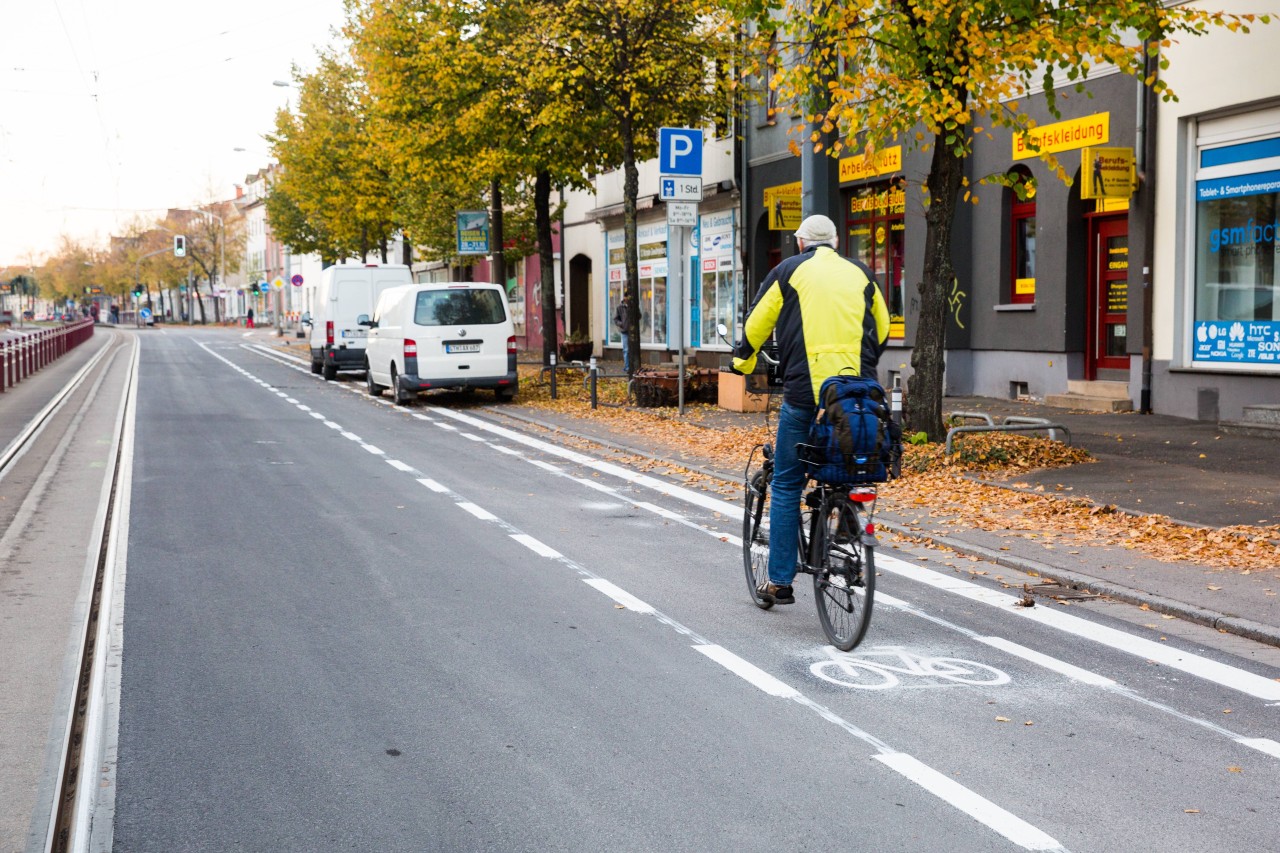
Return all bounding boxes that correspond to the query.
[804,374,892,485]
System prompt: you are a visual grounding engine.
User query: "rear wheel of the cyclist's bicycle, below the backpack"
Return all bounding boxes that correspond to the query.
[813,500,876,652]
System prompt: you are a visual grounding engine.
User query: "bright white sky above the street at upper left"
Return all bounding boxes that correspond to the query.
[0,0,343,268]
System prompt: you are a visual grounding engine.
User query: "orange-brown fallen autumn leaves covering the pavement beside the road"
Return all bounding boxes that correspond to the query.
[501,368,1280,571]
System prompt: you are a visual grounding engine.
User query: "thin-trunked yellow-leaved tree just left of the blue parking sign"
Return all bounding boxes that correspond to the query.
[530,0,733,366]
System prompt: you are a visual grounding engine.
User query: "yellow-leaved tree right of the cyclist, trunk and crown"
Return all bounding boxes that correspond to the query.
[731,0,1267,438]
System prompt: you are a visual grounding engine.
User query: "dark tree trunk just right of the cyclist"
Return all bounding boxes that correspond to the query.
[902,138,964,442]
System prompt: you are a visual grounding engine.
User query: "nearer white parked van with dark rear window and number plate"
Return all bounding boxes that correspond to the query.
[358,282,517,403]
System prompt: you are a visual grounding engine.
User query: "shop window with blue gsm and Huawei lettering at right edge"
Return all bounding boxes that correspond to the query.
[1192,126,1280,366]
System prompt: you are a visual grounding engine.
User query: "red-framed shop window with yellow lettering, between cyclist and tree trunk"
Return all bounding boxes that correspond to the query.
[845,178,906,339]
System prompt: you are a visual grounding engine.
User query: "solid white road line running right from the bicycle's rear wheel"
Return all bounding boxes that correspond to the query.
[876,555,1280,699]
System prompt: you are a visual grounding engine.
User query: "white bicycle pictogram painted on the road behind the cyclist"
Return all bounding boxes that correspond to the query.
[809,646,1010,690]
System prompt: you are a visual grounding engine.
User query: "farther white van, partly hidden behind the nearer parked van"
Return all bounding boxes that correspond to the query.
[302,258,413,382]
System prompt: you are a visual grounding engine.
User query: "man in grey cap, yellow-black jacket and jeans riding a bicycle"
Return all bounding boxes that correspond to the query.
[733,214,888,605]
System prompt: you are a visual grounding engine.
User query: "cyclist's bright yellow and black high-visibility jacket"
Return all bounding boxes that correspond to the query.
[733,246,888,409]
